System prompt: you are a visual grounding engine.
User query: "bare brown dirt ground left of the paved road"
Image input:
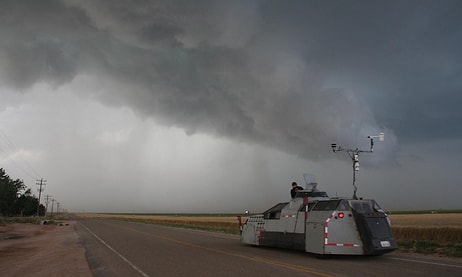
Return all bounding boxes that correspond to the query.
[0,221,92,277]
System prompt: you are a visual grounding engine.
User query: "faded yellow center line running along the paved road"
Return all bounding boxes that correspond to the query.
[123,224,335,277]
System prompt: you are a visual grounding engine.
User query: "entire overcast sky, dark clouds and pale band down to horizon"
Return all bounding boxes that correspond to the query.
[0,0,462,213]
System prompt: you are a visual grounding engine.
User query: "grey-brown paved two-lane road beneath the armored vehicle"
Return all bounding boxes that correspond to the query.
[77,219,462,277]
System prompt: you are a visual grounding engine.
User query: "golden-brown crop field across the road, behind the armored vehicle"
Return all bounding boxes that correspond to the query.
[77,213,462,257]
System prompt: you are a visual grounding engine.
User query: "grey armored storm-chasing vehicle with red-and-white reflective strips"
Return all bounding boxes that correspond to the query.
[241,184,398,255]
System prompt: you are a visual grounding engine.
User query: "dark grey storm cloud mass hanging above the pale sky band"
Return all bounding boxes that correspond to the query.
[0,0,462,162]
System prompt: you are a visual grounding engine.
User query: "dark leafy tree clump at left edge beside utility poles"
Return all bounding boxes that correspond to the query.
[0,168,45,216]
